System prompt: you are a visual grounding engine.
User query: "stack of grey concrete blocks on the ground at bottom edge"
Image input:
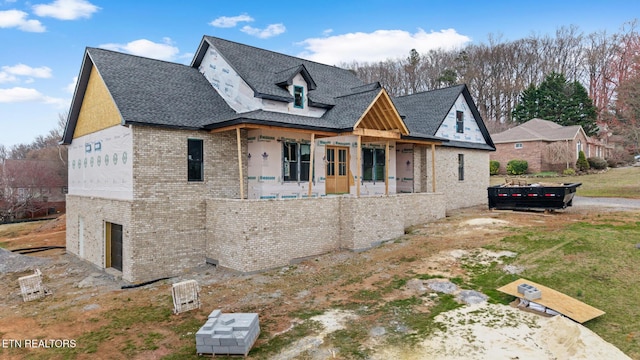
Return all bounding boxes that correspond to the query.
[196,310,260,356]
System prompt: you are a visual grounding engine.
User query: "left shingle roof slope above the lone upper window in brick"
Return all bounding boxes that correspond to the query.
[87,48,234,129]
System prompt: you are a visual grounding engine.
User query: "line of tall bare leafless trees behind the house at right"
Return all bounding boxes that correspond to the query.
[341,20,640,155]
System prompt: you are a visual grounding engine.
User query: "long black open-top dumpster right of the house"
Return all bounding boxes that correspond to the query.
[487,183,582,210]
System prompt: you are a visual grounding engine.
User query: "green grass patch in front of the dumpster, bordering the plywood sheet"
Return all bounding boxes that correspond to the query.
[480,212,640,359]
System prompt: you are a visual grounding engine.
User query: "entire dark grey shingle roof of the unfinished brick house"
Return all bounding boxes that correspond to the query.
[63,36,493,149]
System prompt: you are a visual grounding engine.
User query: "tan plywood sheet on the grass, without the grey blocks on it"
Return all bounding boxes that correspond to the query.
[498,279,604,324]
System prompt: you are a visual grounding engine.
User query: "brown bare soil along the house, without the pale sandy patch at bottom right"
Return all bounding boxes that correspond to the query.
[0,207,632,359]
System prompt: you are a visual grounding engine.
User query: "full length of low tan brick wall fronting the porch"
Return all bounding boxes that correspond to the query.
[206,193,446,272]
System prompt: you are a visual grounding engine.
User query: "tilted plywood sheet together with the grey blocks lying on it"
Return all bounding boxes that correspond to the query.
[498,279,604,324]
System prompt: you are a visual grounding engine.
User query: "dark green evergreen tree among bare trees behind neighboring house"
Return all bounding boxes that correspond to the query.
[511,72,598,135]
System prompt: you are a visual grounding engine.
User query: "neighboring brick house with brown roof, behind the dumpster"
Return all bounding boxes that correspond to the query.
[491,119,607,174]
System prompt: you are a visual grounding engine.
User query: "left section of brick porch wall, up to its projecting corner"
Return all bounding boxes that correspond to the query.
[206,197,341,272]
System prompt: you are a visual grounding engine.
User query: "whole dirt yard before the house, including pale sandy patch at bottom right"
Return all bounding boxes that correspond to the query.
[0,207,626,359]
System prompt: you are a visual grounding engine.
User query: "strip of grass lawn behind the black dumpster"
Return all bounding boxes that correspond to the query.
[491,166,640,199]
